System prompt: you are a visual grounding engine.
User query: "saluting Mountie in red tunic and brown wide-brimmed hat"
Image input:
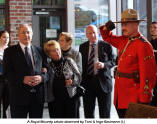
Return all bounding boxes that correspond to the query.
[100,9,156,118]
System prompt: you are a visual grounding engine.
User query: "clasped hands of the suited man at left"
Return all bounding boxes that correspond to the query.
[23,75,42,87]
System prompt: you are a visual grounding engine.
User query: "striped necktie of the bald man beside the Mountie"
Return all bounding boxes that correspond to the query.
[87,44,96,75]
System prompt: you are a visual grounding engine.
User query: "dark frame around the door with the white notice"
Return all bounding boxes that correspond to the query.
[32,7,67,47]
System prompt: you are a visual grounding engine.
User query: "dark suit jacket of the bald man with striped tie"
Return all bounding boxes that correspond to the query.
[79,41,115,93]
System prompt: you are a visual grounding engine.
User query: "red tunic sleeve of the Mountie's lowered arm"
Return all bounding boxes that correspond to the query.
[137,42,156,103]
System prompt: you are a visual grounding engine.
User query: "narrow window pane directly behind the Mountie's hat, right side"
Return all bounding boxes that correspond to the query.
[135,0,147,37]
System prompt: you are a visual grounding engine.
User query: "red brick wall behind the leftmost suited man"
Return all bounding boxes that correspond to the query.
[9,0,32,45]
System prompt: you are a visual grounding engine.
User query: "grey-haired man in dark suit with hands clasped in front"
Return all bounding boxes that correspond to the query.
[3,24,47,118]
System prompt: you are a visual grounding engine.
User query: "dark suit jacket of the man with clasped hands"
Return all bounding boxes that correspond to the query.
[3,44,48,105]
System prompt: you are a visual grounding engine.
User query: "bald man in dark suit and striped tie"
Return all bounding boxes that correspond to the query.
[79,25,114,118]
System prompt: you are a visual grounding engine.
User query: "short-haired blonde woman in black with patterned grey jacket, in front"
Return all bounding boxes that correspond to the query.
[44,40,81,118]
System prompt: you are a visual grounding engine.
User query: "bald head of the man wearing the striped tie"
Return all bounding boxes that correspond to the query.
[86,25,99,43]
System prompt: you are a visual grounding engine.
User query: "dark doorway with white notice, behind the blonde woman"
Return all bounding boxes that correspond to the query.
[32,9,67,47]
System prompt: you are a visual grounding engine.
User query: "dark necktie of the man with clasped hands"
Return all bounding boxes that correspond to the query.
[25,47,34,75]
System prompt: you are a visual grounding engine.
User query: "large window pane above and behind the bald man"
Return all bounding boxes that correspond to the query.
[74,0,108,45]
